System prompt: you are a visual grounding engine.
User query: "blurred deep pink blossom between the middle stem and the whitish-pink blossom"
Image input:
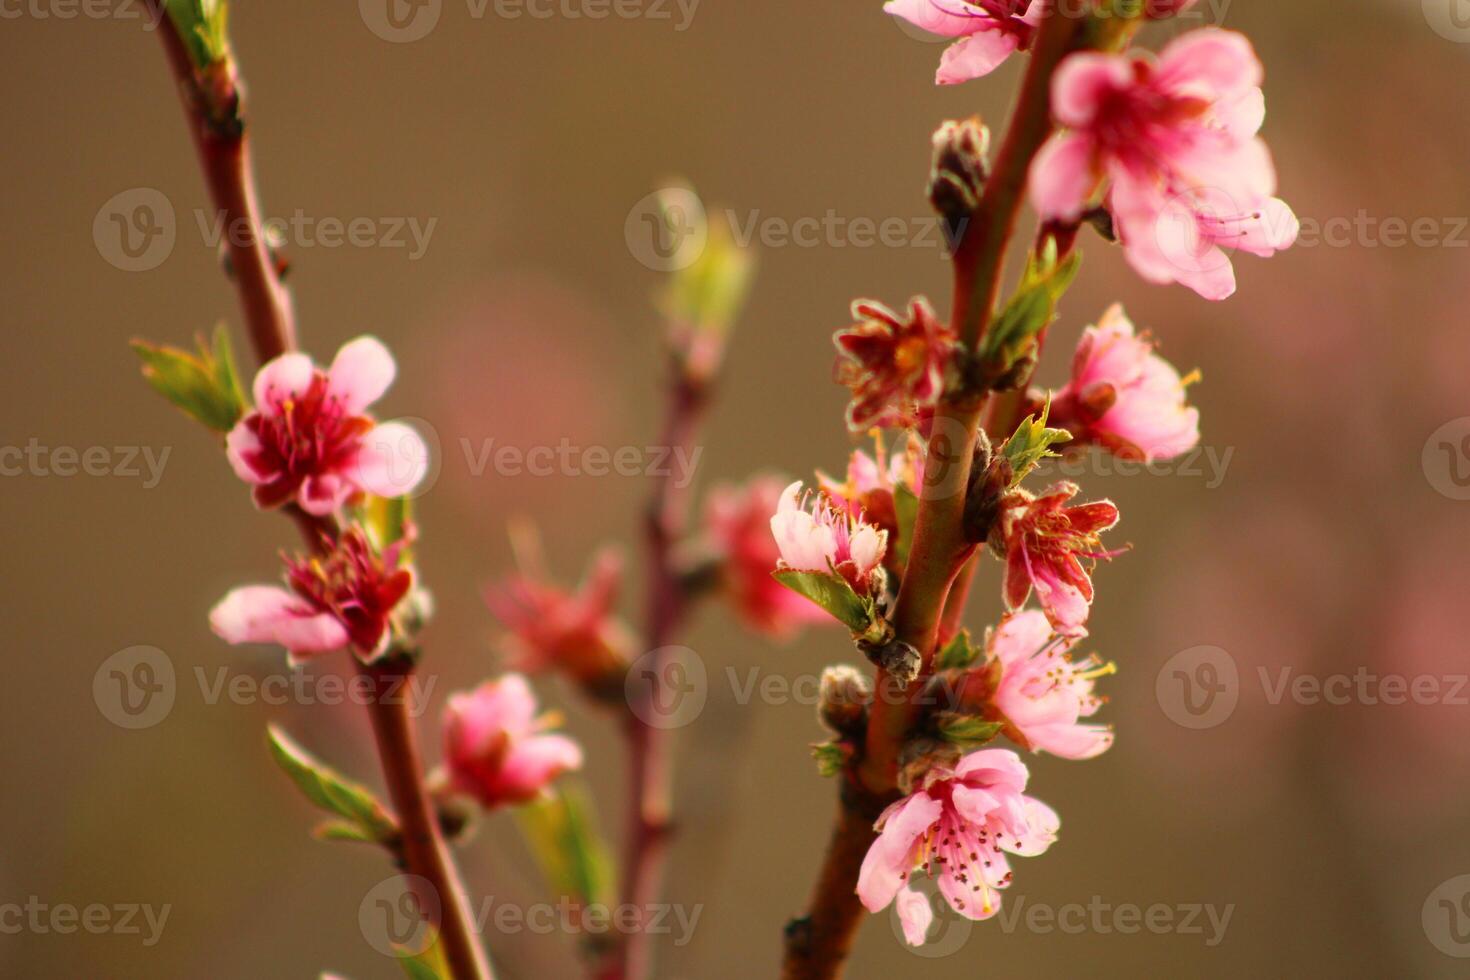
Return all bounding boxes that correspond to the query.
[704,476,832,638]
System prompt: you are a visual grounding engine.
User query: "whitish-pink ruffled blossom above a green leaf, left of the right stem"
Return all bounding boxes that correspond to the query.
[770,480,888,595]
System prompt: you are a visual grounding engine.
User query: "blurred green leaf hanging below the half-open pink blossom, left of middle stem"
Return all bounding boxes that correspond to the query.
[516,779,613,902]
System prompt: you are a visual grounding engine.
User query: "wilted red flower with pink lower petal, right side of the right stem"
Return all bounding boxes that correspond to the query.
[1001,482,1117,636]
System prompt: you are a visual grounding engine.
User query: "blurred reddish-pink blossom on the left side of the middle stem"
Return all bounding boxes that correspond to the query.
[485,548,634,692]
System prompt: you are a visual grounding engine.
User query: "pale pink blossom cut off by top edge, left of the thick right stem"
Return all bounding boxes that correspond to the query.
[883,0,1044,85]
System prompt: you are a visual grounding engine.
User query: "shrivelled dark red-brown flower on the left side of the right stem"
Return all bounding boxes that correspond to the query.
[833,297,954,432]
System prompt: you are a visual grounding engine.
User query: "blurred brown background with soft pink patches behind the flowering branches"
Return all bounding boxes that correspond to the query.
[0,0,1470,980]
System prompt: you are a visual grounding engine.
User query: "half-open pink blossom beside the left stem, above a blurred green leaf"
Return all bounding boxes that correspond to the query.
[444,674,582,810]
